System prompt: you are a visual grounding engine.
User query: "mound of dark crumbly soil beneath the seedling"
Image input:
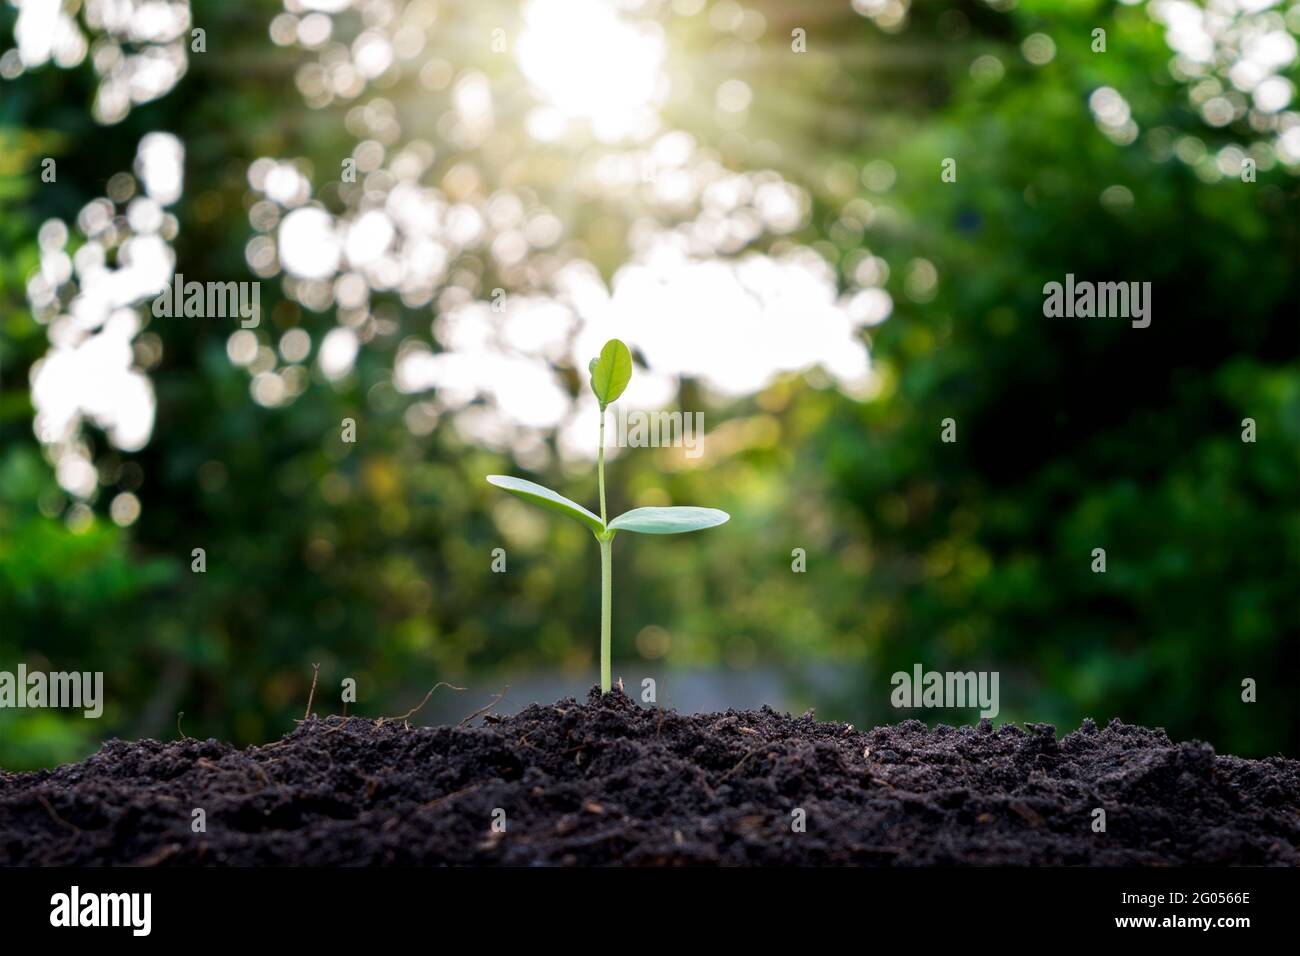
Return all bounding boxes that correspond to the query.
[0,692,1300,865]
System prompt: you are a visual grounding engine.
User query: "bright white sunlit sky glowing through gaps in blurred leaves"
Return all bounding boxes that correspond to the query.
[10,0,1300,498]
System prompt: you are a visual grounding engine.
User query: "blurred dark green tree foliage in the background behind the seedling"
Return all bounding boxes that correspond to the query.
[0,0,1300,767]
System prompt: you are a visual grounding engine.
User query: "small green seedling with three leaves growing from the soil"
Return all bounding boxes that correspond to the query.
[488,338,731,693]
